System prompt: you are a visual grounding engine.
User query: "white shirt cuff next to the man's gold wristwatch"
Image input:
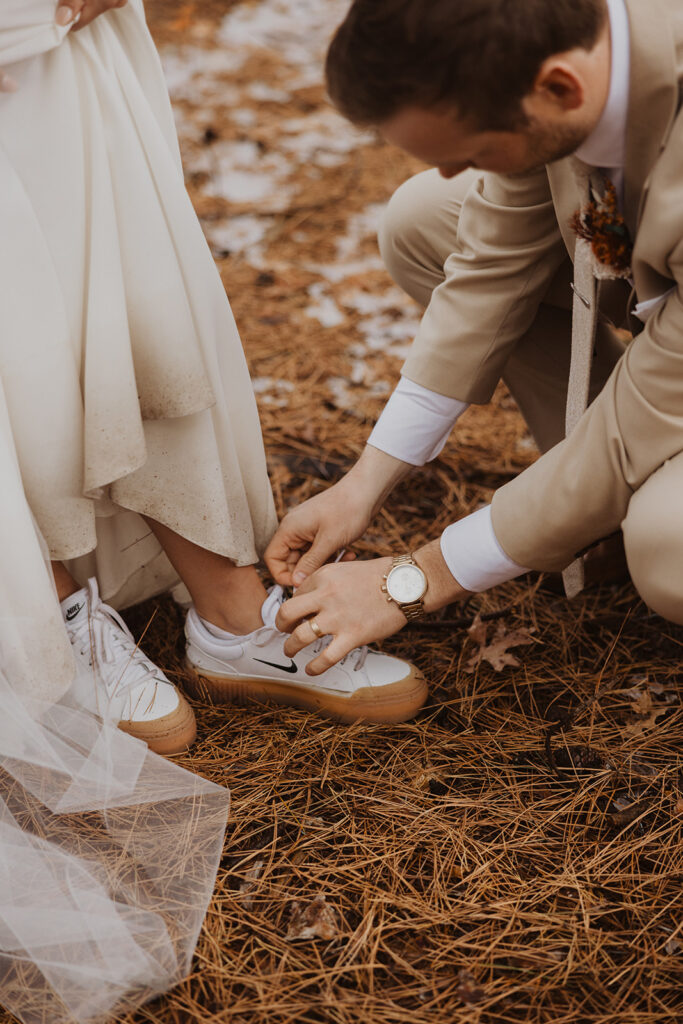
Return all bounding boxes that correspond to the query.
[441,505,529,594]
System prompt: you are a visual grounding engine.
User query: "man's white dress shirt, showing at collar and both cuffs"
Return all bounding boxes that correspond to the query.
[368,0,630,592]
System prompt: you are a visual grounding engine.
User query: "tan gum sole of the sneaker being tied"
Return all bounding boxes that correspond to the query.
[183,660,428,725]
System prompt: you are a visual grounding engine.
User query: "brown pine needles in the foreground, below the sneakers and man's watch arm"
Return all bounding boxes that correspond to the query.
[118,569,683,1024]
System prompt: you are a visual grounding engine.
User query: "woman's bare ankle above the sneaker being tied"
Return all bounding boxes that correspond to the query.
[145,517,266,636]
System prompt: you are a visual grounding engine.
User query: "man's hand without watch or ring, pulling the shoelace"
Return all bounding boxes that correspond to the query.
[264,445,412,587]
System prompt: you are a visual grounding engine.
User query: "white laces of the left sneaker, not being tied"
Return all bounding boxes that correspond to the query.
[67,580,158,702]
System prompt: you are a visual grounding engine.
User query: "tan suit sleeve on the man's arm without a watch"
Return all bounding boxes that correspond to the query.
[402,169,566,403]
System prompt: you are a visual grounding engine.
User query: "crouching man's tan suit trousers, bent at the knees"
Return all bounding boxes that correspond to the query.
[379,171,683,623]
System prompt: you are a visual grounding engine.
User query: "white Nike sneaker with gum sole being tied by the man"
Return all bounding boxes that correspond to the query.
[185,587,427,723]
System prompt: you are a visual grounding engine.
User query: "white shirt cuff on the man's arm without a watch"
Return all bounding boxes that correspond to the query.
[368,377,468,466]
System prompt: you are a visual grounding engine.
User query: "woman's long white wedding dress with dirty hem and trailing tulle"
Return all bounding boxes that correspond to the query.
[0,0,274,1024]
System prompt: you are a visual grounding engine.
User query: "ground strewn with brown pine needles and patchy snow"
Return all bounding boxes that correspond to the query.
[5,0,683,1024]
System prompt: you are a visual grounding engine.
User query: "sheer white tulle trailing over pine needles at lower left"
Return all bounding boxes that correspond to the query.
[0,364,229,1024]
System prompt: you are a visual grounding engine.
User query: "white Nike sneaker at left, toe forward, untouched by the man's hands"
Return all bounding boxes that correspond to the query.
[61,579,197,754]
